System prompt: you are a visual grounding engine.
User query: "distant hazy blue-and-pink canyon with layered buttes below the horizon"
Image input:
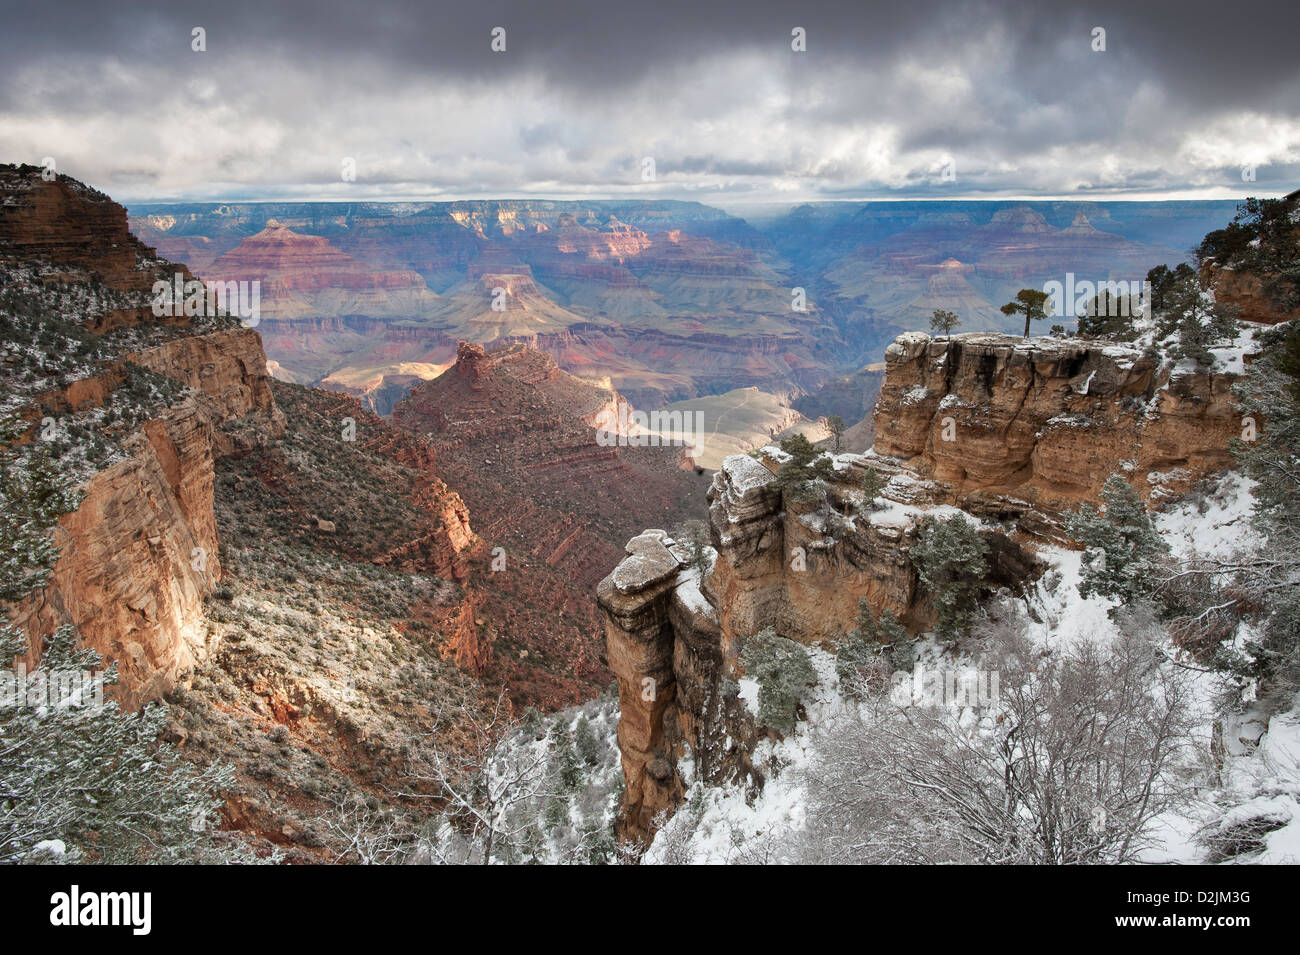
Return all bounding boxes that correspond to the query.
[131,200,1231,415]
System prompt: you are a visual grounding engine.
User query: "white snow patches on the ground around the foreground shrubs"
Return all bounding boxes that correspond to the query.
[644,473,1300,864]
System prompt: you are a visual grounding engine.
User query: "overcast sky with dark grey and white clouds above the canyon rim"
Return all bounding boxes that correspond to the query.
[0,0,1300,208]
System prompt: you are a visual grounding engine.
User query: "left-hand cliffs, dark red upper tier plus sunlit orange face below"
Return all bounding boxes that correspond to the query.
[0,166,281,708]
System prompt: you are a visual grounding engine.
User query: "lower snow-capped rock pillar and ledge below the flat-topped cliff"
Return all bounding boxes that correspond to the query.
[597,451,1041,842]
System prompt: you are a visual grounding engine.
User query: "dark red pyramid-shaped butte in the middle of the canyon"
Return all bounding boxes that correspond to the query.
[393,342,707,702]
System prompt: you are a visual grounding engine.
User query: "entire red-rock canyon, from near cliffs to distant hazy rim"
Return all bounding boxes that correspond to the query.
[0,166,1284,861]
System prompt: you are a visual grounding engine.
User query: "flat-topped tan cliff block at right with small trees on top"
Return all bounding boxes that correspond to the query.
[874,331,1242,511]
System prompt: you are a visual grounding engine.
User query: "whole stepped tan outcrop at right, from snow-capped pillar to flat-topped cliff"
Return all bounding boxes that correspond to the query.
[597,333,1242,841]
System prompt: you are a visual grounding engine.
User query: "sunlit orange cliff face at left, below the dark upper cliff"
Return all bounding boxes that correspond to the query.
[13,329,282,708]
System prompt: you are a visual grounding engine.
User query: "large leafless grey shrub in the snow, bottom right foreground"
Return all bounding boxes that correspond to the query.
[801,615,1193,864]
